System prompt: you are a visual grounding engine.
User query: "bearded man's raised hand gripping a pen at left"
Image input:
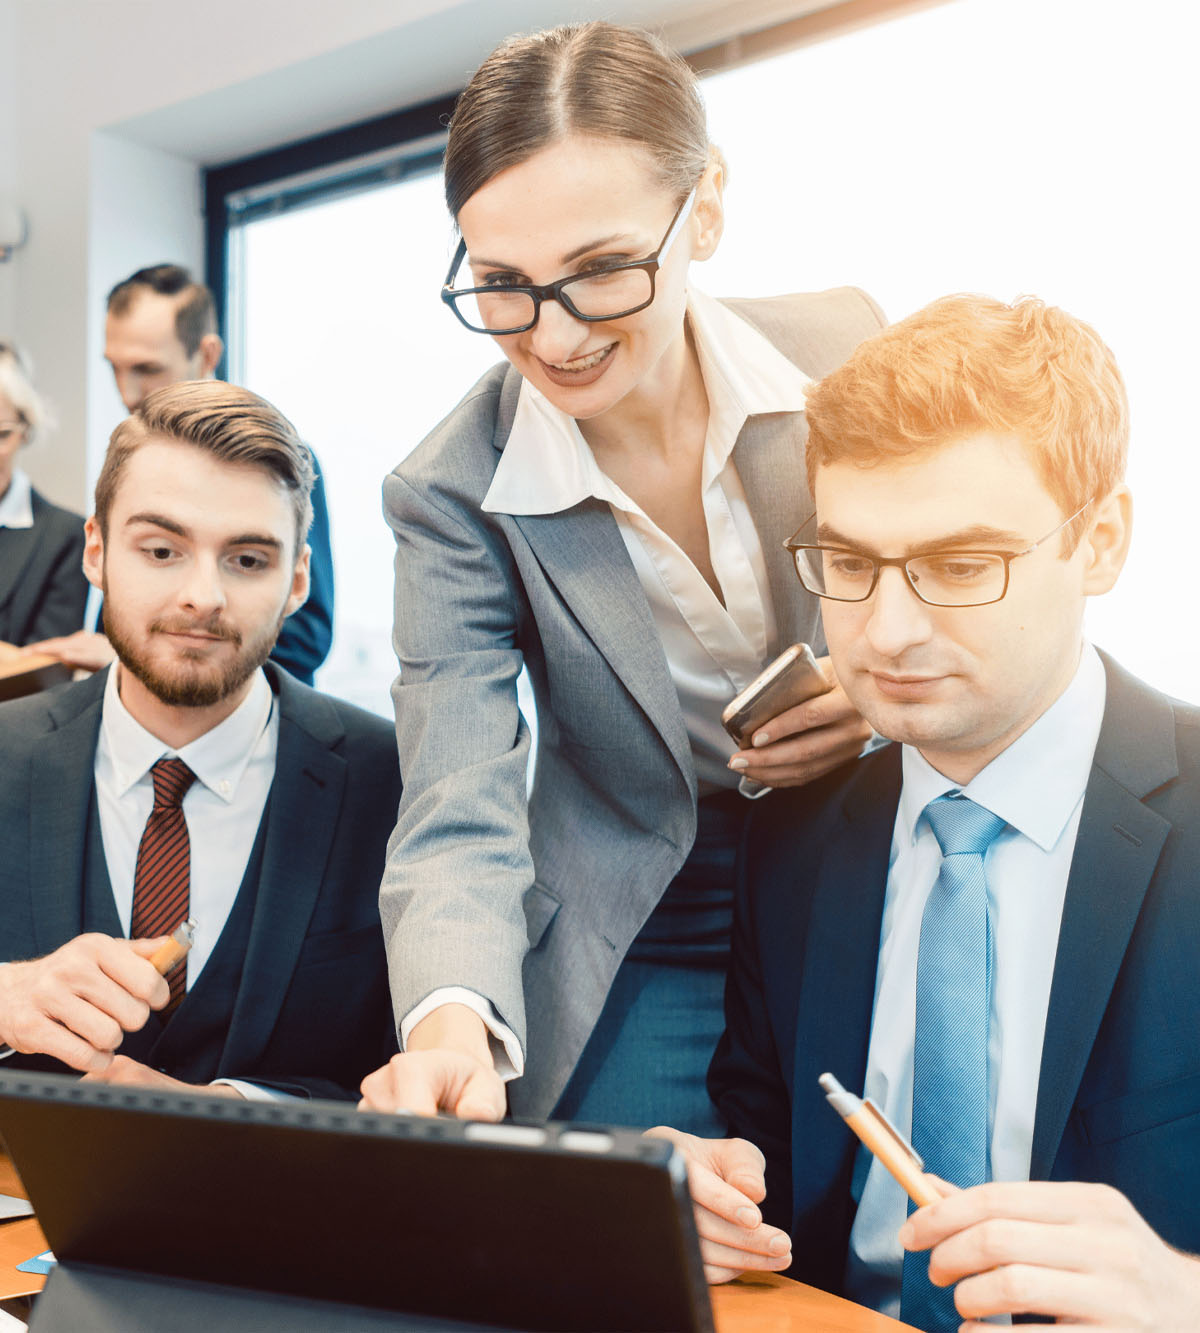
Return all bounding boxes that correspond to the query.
[0,934,178,1073]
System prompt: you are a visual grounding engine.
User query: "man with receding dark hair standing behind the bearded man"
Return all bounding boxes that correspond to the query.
[28,264,333,685]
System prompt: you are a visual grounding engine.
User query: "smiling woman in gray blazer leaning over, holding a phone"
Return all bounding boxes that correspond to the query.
[364,23,883,1133]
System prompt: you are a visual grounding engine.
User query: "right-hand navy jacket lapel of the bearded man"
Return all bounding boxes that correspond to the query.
[221,664,345,1069]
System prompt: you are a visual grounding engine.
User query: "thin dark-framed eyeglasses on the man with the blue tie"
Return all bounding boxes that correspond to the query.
[784,500,1092,607]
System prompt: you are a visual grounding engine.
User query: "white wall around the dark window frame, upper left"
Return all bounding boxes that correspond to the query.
[0,0,829,509]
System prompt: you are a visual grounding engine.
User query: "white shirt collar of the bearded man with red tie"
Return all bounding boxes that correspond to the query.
[100,667,275,805]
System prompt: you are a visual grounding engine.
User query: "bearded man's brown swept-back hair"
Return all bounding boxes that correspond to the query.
[96,380,316,553]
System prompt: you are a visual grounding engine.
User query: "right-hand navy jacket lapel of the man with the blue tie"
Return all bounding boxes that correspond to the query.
[1029,655,1179,1180]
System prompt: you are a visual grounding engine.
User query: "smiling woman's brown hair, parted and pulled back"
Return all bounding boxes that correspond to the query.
[445,21,716,219]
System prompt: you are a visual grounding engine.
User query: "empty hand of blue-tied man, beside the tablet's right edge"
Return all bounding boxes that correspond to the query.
[647,1125,792,1284]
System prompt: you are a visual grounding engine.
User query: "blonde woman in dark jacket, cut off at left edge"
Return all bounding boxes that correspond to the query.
[0,343,88,647]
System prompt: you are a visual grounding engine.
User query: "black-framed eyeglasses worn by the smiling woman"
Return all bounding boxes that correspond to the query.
[441,189,696,336]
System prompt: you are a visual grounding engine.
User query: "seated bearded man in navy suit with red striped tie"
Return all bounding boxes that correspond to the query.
[0,383,400,1098]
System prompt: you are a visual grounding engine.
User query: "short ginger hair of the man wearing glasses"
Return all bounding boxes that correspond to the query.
[805,295,1129,555]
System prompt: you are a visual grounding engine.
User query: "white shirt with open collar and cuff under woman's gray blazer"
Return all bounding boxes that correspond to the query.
[400,288,812,1077]
